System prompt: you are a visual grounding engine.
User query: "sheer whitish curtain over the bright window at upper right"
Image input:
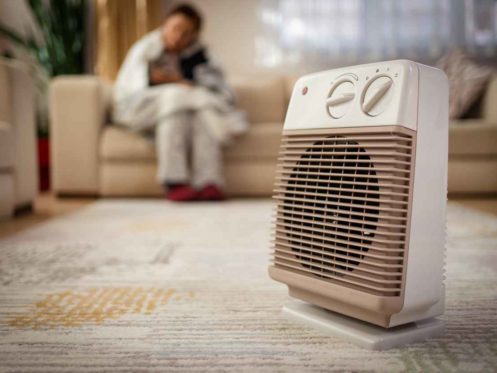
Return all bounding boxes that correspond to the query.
[255,0,497,69]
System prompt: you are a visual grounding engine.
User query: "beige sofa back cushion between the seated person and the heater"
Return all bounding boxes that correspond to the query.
[230,77,286,124]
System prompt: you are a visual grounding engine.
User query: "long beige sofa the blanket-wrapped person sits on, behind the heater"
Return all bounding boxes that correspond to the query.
[50,71,497,197]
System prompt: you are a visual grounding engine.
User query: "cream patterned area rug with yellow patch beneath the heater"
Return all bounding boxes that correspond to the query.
[0,200,497,372]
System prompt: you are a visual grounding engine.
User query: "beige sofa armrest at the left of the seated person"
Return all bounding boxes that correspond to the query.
[50,76,108,195]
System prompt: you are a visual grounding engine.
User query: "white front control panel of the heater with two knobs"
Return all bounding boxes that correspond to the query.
[285,60,420,130]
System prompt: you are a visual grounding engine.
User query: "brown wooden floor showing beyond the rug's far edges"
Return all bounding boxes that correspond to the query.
[0,192,497,238]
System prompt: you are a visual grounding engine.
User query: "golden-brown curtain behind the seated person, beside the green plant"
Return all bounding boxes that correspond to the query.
[95,0,164,81]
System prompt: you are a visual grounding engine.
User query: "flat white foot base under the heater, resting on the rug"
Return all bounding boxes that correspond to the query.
[282,300,445,350]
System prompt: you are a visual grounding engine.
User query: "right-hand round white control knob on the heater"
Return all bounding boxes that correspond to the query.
[361,75,393,117]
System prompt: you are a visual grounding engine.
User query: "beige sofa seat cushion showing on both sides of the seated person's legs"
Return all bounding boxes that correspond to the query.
[100,122,283,161]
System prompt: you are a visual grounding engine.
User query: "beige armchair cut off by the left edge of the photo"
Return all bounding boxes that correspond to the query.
[0,59,38,218]
